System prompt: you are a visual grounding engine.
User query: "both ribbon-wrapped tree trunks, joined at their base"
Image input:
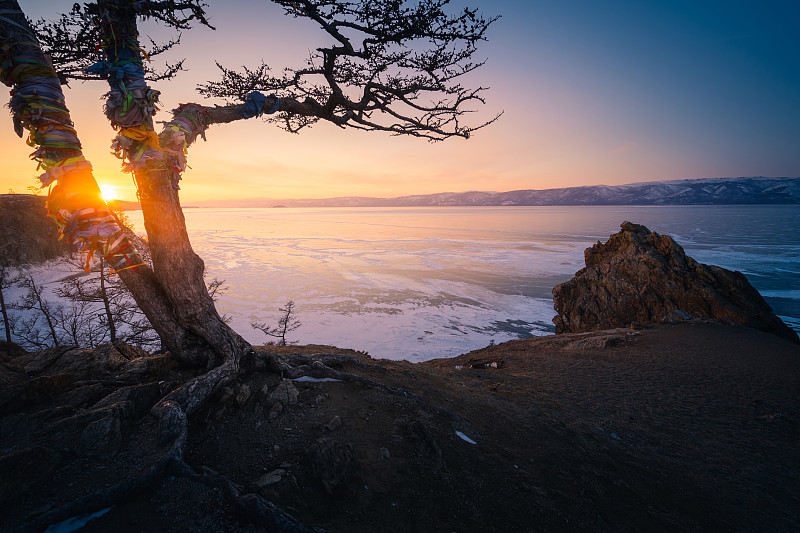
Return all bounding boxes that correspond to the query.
[0,0,260,390]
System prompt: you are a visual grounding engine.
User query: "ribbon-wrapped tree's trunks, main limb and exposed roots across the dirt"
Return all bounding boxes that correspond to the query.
[0,0,504,533]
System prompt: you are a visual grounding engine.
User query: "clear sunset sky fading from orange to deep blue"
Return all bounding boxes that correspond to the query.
[0,0,800,204]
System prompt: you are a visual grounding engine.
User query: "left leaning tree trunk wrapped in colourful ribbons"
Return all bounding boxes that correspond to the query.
[0,0,207,366]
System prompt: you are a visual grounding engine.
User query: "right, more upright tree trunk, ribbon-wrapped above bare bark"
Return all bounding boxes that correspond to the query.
[90,0,251,370]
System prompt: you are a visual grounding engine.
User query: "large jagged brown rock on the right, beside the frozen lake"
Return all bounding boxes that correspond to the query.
[553,222,799,343]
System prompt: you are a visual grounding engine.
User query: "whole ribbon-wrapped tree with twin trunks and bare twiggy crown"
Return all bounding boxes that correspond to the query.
[0,0,497,531]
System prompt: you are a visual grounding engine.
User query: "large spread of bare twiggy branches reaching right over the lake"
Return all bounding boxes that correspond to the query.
[198,0,500,141]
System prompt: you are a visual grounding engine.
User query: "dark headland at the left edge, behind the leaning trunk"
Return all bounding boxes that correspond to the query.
[0,194,69,265]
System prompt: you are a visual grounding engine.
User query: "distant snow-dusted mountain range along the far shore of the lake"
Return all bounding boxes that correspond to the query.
[193,177,800,207]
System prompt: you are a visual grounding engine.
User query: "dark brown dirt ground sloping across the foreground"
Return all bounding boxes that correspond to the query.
[0,321,800,533]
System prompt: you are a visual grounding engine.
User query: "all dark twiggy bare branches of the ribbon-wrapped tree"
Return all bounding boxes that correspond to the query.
[35,0,500,141]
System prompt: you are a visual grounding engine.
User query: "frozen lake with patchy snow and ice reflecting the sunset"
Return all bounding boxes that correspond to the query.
[122,206,800,361]
